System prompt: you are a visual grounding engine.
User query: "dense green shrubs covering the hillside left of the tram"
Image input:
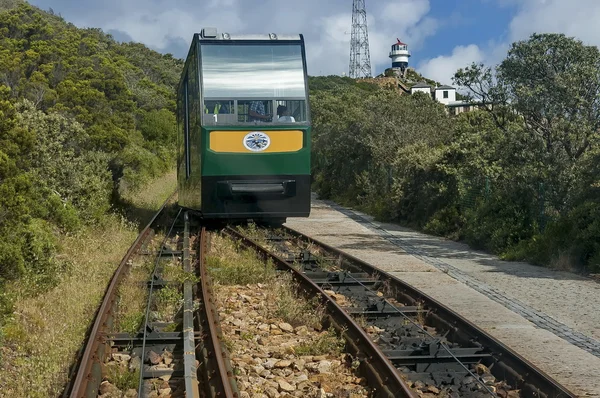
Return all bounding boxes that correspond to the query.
[0,0,182,304]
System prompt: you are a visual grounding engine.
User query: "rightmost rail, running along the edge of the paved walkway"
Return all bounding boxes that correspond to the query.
[283,226,576,398]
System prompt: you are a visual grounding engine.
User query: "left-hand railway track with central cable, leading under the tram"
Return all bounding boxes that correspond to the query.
[63,200,239,398]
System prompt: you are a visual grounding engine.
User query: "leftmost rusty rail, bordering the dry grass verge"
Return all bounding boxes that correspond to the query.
[65,192,176,398]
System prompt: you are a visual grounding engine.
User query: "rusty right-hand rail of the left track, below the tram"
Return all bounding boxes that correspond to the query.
[195,228,240,398]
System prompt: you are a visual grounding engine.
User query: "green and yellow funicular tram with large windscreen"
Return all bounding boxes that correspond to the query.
[177,28,310,222]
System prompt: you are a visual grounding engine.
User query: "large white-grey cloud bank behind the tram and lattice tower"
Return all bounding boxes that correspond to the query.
[30,0,440,74]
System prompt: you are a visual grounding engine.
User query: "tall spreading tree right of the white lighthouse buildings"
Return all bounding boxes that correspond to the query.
[454,34,600,211]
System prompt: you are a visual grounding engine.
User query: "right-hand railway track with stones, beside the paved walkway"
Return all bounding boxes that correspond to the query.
[225,224,575,398]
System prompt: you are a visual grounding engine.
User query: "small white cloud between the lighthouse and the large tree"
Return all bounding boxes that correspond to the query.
[417,44,486,84]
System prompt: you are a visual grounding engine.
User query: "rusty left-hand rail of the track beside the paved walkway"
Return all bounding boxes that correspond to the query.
[223,227,417,398]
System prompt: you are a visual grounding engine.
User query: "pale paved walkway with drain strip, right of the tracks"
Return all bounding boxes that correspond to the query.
[287,200,600,397]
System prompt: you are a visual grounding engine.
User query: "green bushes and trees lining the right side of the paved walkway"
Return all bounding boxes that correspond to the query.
[310,34,600,272]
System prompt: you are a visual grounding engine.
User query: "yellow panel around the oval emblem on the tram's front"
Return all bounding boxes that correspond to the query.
[209,130,303,153]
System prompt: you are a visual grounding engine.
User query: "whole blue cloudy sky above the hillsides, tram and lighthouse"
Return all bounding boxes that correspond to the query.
[24,0,600,84]
